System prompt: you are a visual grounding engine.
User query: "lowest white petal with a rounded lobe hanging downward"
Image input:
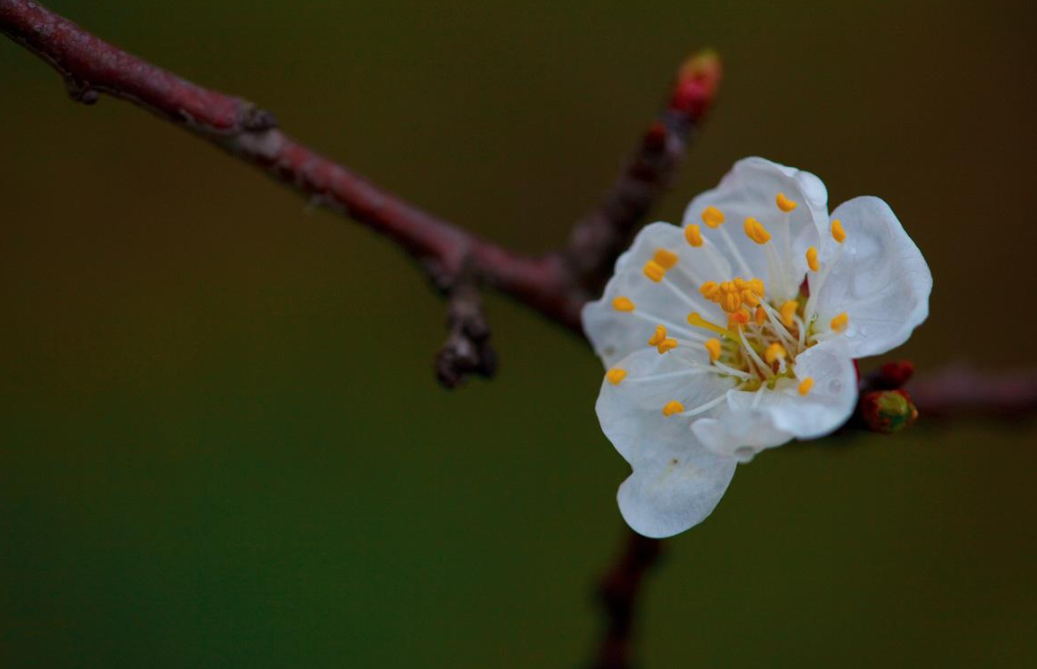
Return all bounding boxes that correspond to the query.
[596,349,736,537]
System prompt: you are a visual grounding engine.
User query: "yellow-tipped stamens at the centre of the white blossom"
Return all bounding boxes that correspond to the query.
[606,188,849,416]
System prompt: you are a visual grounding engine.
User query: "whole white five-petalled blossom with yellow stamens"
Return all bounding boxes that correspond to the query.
[583,158,932,537]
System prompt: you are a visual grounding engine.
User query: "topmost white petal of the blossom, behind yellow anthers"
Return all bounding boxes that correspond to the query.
[684,158,828,300]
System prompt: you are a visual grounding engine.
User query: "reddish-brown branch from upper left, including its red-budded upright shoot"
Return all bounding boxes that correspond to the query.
[0,0,719,385]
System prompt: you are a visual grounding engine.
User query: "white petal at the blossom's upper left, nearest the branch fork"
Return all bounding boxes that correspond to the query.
[582,223,726,367]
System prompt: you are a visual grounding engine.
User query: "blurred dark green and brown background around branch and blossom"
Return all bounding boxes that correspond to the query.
[0,0,1037,668]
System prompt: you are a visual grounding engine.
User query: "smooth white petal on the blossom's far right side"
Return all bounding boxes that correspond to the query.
[816,197,932,358]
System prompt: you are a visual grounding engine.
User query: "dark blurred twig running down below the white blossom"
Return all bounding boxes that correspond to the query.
[591,530,663,669]
